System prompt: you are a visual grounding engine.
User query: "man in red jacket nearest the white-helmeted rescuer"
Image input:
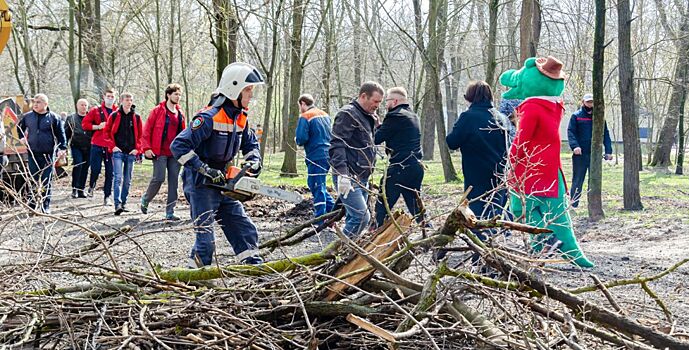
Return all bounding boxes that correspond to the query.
[141,84,185,221]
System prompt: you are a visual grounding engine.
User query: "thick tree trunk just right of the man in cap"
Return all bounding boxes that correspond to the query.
[617,0,643,210]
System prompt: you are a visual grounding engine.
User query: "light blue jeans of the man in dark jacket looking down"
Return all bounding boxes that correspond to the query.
[335,177,371,238]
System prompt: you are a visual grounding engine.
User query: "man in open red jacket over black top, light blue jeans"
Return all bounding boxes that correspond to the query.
[105,92,142,215]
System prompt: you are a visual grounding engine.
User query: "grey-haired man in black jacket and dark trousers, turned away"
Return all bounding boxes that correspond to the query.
[374,87,424,227]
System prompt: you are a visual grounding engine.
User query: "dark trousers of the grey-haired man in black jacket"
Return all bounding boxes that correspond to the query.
[376,162,424,227]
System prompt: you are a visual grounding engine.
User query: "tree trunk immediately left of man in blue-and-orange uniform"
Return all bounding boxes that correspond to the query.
[280,0,306,177]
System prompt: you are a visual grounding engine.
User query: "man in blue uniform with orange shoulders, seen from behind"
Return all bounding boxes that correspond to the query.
[296,94,335,223]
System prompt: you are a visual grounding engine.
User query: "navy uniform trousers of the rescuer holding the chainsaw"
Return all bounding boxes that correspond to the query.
[182,168,259,266]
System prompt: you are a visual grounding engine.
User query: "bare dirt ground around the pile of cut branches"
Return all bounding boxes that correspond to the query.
[0,175,689,331]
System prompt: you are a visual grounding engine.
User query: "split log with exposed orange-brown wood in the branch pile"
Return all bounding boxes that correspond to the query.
[325,214,412,301]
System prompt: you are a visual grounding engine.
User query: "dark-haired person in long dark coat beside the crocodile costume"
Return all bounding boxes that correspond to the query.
[445,81,508,234]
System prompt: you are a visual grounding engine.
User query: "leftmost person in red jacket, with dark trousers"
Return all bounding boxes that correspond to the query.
[81,88,117,205]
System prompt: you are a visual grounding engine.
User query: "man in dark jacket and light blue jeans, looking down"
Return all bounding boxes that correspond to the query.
[328,81,385,237]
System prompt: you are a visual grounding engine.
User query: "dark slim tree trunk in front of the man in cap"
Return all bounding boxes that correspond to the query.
[588,0,606,221]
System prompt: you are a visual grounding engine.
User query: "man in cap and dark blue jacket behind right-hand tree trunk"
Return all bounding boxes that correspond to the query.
[567,94,612,208]
